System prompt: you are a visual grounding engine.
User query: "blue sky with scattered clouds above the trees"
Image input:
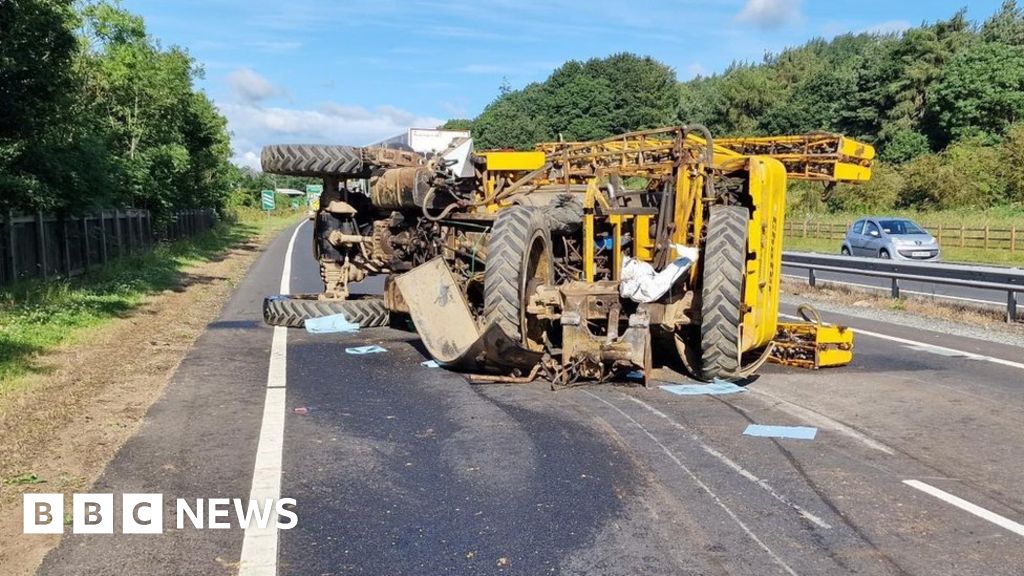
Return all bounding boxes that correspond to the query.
[122,0,1001,168]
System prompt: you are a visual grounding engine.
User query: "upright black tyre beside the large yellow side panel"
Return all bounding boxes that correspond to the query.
[700,206,750,380]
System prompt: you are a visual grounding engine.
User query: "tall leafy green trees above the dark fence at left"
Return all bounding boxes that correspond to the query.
[0,0,248,217]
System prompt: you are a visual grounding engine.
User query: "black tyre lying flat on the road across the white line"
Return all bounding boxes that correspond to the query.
[263,294,389,328]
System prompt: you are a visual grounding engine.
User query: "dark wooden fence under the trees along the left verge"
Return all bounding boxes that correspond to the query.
[0,209,217,286]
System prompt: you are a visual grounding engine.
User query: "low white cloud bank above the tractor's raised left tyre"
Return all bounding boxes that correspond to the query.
[218,102,444,169]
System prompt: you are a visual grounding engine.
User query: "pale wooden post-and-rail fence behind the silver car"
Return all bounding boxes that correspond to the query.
[785,218,1024,253]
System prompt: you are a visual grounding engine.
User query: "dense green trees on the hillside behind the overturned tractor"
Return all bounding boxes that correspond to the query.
[453,1,1024,209]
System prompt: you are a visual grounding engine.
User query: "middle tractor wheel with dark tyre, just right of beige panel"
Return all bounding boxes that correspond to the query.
[483,206,555,351]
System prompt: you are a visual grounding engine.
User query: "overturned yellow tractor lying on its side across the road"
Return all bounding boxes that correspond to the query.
[263,126,874,384]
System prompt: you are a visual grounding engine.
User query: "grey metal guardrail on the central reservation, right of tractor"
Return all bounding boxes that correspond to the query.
[782,252,1024,322]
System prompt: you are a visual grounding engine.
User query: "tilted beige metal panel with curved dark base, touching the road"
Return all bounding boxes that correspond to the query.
[395,258,543,373]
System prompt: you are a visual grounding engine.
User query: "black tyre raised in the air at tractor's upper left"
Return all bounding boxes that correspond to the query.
[260,145,367,177]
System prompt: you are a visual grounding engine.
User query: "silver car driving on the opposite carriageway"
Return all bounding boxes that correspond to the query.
[841,217,939,260]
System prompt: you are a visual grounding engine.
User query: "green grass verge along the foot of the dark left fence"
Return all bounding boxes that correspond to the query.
[0,207,297,399]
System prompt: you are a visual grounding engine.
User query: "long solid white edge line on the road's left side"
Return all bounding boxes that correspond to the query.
[239,220,306,576]
